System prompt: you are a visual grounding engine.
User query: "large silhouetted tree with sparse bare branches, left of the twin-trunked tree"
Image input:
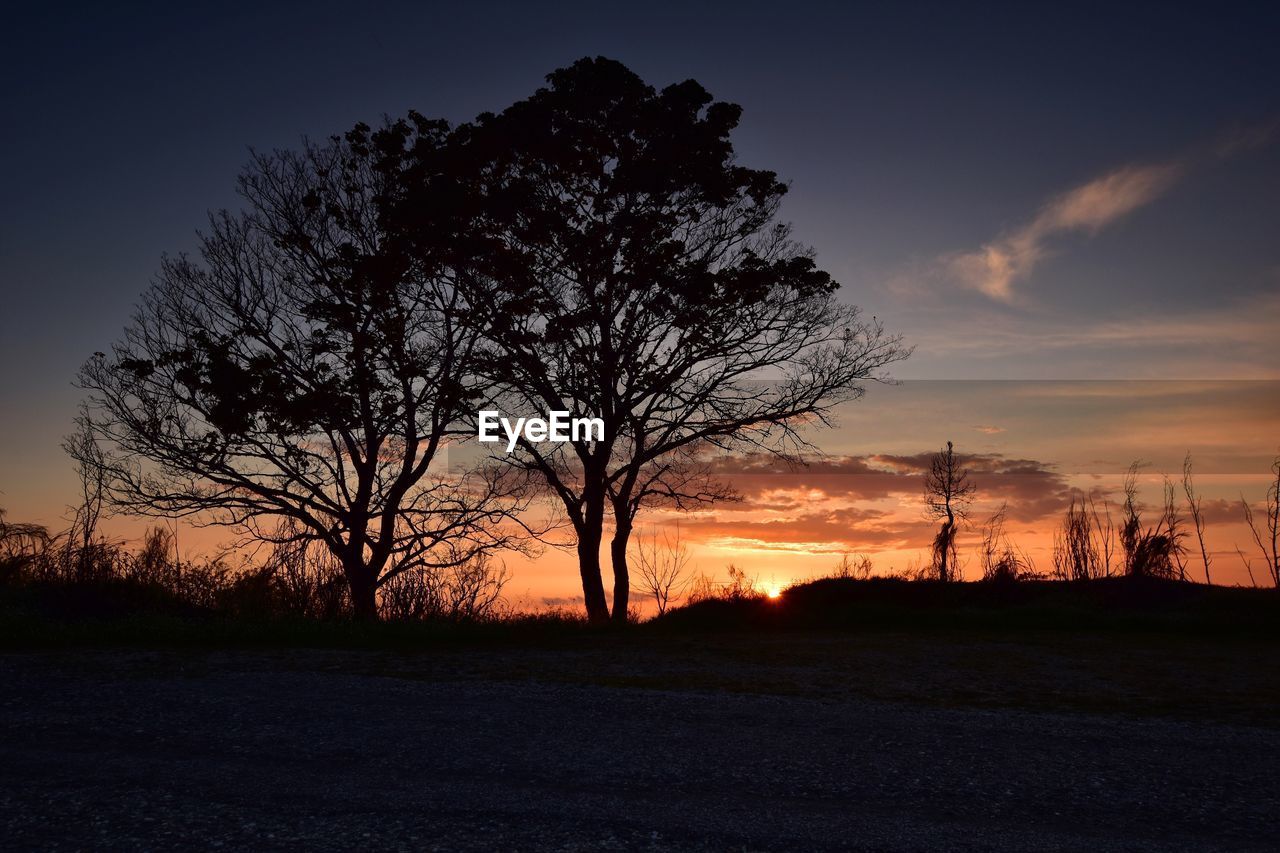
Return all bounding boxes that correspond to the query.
[72,122,532,617]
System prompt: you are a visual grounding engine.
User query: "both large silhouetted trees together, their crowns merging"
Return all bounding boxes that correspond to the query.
[81,58,908,621]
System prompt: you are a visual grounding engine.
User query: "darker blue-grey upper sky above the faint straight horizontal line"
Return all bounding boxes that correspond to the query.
[0,3,1280,514]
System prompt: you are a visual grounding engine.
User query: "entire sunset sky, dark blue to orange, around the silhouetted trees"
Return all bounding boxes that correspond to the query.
[0,3,1280,601]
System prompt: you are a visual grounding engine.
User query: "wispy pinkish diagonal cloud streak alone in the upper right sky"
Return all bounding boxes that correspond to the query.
[945,163,1184,302]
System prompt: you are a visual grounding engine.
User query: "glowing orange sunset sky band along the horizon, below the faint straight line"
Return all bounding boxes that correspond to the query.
[0,380,1280,611]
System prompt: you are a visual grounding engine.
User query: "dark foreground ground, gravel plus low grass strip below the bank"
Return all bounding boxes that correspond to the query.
[0,631,1280,850]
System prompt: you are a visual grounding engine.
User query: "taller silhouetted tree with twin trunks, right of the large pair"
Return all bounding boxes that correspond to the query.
[403,59,906,621]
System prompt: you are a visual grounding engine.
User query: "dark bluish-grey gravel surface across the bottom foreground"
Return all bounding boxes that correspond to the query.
[0,652,1280,850]
